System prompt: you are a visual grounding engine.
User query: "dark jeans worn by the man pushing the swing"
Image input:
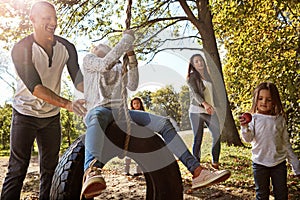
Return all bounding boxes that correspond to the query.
[1,110,61,200]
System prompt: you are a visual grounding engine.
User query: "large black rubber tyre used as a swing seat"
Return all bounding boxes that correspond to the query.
[50,123,183,200]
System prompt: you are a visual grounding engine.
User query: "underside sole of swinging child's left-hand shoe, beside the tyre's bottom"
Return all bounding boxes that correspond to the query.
[82,178,106,199]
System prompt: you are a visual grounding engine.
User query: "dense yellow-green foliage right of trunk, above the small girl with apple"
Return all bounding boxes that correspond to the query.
[212,0,300,152]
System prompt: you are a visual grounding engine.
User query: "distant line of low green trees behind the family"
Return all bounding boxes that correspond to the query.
[0,85,299,155]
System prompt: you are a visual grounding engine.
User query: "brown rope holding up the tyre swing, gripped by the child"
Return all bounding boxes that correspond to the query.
[119,0,132,156]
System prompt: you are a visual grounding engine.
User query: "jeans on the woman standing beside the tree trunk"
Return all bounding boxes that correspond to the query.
[190,113,221,163]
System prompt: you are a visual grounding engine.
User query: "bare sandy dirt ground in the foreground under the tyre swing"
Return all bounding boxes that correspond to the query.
[0,157,254,200]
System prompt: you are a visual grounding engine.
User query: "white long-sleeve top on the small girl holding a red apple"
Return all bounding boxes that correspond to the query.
[241,114,299,167]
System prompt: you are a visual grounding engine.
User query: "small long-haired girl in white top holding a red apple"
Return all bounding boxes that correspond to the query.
[240,82,299,199]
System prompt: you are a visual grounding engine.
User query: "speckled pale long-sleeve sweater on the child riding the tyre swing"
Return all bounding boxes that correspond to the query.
[83,34,139,111]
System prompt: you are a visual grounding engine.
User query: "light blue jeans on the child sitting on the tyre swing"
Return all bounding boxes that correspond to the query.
[84,107,200,173]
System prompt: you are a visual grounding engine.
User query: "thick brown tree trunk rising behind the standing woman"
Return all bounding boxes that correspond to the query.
[180,0,243,146]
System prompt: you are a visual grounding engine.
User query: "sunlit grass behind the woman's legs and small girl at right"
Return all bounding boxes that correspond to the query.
[179,131,300,200]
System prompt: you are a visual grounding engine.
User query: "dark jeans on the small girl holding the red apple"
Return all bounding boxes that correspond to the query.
[252,161,288,200]
